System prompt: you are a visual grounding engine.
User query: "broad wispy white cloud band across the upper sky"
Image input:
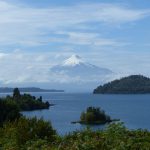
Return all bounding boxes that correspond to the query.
[0,0,150,46]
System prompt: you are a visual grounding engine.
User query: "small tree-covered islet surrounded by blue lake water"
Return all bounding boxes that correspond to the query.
[72,107,113,125]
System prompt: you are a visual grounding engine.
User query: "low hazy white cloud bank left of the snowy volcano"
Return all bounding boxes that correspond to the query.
[0,50,77,86]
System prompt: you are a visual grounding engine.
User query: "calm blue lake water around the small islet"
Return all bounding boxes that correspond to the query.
[1,93,150,135]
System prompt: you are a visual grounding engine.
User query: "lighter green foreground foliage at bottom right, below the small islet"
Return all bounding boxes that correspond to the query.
[56,124,150,150]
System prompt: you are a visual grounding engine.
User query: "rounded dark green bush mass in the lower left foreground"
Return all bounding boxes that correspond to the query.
[0,117,56,150]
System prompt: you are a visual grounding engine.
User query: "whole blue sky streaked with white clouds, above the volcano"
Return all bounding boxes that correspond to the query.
[0,0,150,90]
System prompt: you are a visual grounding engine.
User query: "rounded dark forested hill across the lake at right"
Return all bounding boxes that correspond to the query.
[93,75,150,94]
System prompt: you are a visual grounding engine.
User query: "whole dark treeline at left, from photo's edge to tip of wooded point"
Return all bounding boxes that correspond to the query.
[0,88,50,125]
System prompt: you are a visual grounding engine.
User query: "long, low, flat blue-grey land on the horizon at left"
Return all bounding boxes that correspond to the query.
[0,87,64,93]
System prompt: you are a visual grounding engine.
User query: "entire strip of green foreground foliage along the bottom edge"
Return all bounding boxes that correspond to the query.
[0,118,150,150]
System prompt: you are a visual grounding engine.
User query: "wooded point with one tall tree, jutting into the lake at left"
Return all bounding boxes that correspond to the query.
[1,88,50,111]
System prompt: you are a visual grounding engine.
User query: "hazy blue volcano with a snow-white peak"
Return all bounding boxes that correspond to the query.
[51,55,112,77]
